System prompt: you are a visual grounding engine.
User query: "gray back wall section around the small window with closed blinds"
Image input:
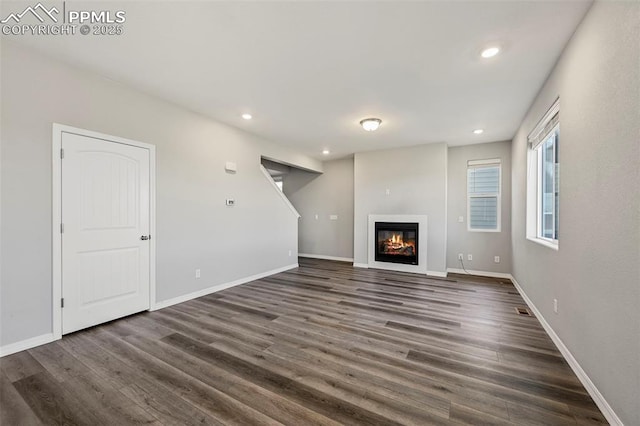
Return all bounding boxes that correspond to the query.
[447,141,511,273]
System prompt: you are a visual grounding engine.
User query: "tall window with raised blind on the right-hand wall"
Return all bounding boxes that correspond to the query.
[527,100,560,249]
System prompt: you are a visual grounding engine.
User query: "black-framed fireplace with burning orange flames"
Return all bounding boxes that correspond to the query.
[374,222,418,265]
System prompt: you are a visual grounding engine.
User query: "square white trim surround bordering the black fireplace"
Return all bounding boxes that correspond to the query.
[367,214,427,274]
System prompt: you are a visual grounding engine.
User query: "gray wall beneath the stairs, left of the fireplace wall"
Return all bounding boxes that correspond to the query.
[284,158,353,259]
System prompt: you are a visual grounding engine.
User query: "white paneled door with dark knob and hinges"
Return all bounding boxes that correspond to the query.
[62,132,153,334]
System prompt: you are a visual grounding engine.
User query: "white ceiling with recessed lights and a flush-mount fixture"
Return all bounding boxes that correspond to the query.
[3,0,591,158]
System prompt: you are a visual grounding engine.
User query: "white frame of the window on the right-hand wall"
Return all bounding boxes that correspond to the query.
[525,99,560,250]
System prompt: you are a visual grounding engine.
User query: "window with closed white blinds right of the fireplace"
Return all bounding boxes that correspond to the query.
[467,159,501,232]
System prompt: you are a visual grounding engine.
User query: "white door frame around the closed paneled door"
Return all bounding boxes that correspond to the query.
[51,123,157,340]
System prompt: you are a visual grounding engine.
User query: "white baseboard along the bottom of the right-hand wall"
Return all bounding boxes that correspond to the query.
[509,275,623,426]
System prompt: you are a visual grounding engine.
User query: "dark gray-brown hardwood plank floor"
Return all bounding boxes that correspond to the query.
[0,259,606,426]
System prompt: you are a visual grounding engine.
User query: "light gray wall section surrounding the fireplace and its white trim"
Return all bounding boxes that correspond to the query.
[353,143,447,273]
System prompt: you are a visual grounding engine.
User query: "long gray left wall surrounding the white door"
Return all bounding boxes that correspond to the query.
[0,40,322,345]
